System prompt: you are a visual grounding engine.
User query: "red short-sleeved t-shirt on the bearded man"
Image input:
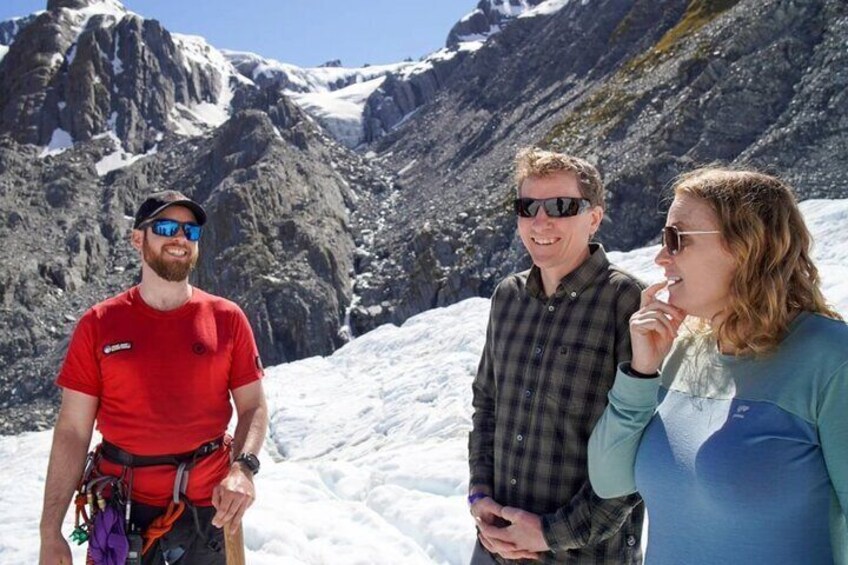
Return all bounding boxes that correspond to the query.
[56,287,262,506]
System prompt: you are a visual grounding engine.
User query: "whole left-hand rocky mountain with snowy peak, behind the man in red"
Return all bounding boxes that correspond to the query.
[0,0,388,432]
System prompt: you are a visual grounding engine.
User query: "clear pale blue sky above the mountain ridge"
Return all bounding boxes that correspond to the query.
[0,0,477,67]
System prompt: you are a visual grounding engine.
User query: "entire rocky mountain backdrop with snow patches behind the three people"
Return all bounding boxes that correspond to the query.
[0,0,848,432]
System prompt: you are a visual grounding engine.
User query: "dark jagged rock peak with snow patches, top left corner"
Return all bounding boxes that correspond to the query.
[0,0,237,153]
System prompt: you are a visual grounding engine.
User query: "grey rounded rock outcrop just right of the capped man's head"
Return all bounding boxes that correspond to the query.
[157,100,354,363]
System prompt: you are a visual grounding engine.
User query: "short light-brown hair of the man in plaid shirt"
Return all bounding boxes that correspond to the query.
[515,147,605,208]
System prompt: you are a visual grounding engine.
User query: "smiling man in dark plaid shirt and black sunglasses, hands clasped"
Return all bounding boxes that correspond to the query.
[468,149,643,565]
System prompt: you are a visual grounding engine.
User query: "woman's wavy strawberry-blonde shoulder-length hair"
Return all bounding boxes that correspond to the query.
[672,167,841,354]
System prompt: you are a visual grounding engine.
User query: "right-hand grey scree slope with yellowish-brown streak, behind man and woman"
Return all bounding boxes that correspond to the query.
[352,0,848,332]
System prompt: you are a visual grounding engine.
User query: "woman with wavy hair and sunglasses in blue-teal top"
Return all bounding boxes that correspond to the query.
[589,168,848,565]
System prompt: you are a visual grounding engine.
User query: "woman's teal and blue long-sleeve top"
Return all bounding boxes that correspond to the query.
[589,313,848,565]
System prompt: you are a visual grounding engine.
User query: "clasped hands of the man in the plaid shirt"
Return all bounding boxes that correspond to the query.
[478,501,550,559]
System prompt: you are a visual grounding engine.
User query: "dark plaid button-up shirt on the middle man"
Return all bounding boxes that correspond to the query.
[468,244,643,565]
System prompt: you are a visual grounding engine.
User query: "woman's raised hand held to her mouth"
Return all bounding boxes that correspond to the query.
[630,281,686,375]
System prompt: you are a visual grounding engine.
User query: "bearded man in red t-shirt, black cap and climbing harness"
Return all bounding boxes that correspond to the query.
[40,191,268,565]
